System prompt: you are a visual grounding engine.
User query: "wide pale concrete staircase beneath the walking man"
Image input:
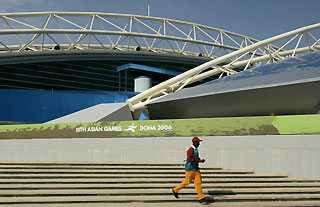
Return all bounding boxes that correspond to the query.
[0,162,320,207]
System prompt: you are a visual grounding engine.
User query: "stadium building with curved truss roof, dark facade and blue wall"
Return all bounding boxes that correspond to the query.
[0,12,257,123]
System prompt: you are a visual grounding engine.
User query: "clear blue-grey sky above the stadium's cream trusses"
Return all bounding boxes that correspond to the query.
[0,0,320,40]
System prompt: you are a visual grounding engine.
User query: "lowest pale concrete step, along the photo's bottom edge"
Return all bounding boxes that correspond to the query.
[0,194,320,205]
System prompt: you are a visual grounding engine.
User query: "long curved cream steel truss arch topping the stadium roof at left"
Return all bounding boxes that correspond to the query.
[0,12,264,59]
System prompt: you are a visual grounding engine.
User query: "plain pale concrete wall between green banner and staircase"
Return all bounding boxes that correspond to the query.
[0,135,320,178]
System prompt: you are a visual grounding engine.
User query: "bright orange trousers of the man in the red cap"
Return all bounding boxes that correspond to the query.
[173,170,204,200]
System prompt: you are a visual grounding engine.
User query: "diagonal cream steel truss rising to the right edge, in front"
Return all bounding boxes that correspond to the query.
[127,23,320,118]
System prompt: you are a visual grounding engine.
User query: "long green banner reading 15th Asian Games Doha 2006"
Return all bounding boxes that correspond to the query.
[0,115,320,139]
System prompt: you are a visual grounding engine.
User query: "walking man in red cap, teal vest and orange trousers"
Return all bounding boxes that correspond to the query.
[172,137,206,203]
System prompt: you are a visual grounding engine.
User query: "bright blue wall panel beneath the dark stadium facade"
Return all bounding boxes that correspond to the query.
[0,89,137,123]
